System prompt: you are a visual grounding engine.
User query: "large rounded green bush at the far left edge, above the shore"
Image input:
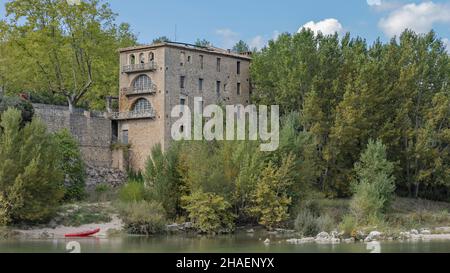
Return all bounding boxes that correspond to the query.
[0,109,64,225]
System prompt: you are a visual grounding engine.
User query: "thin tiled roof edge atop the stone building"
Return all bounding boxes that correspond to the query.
[119,42,251,60]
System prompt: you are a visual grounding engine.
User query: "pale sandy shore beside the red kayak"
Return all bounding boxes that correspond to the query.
[14,215,123,239]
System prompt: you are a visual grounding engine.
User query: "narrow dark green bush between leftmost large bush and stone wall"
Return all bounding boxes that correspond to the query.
[53,129,86,201]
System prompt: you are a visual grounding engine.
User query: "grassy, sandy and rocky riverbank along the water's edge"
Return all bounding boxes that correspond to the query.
[0,198,450,244]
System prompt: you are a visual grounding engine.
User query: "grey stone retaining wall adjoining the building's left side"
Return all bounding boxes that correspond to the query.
[33,104,112,168]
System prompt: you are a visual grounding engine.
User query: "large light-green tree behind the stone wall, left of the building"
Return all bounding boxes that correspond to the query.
[4,0,136,109]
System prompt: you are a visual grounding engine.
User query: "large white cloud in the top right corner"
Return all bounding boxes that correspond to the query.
[378,2,450,37]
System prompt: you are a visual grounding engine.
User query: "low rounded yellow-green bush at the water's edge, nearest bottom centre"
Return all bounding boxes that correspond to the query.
[182,191,234,233]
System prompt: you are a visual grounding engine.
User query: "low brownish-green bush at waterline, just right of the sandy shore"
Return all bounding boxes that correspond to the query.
[119,201,166,235]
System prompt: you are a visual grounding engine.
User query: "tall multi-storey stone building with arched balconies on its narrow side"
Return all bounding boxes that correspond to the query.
[112,42,251,170]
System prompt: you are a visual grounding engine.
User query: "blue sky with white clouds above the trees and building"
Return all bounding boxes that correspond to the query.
[0,0,450,48]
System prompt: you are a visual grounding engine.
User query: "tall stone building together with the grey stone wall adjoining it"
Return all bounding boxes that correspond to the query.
[33,43,251,173]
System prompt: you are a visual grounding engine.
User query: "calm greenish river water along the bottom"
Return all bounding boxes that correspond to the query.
[0,234,450,253]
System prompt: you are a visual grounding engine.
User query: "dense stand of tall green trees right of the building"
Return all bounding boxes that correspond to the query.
[251,30,450,199]
